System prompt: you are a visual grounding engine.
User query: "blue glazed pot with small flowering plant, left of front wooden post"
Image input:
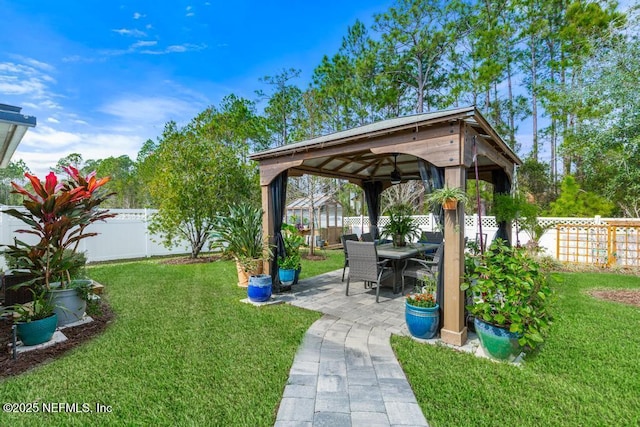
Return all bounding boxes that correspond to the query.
[405,273,440,339]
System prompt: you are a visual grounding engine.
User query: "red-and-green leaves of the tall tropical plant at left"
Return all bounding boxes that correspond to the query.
[4,166,115,289]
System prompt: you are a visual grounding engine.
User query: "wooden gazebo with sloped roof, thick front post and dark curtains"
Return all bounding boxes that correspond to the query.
[250,107,522,346]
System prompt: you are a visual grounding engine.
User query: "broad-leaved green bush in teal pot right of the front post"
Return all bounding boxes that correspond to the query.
[461,239,552,349]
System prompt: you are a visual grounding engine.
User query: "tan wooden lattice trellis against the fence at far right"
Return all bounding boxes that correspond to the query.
[556,220,640,268]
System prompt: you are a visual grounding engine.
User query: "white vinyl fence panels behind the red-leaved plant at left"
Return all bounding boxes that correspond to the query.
[0,206,190,267]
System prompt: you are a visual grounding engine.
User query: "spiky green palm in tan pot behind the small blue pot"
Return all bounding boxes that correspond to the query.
[215,204,271,288]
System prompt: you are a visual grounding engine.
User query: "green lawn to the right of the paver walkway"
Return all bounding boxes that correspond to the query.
[392,273,640,426]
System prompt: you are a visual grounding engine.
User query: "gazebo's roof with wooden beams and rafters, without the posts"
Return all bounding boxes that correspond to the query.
[250,107,522,186]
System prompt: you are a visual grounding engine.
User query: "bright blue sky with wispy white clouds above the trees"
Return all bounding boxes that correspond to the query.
[0,0,393,175]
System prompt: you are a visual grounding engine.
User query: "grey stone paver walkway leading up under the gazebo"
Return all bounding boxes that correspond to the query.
[275,270,428,427]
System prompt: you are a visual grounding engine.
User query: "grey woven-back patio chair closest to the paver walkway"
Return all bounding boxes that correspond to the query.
[345,240,395,302]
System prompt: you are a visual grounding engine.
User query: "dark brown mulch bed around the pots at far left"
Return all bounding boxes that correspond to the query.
[0,301,115,379]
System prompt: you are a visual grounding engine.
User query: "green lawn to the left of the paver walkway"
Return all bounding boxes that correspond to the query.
[0,251,343,426]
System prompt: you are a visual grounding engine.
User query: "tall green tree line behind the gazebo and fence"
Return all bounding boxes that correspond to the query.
[0,0,640,256]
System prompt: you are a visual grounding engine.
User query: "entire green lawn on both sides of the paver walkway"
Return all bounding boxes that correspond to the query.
[0,251,640,426]
